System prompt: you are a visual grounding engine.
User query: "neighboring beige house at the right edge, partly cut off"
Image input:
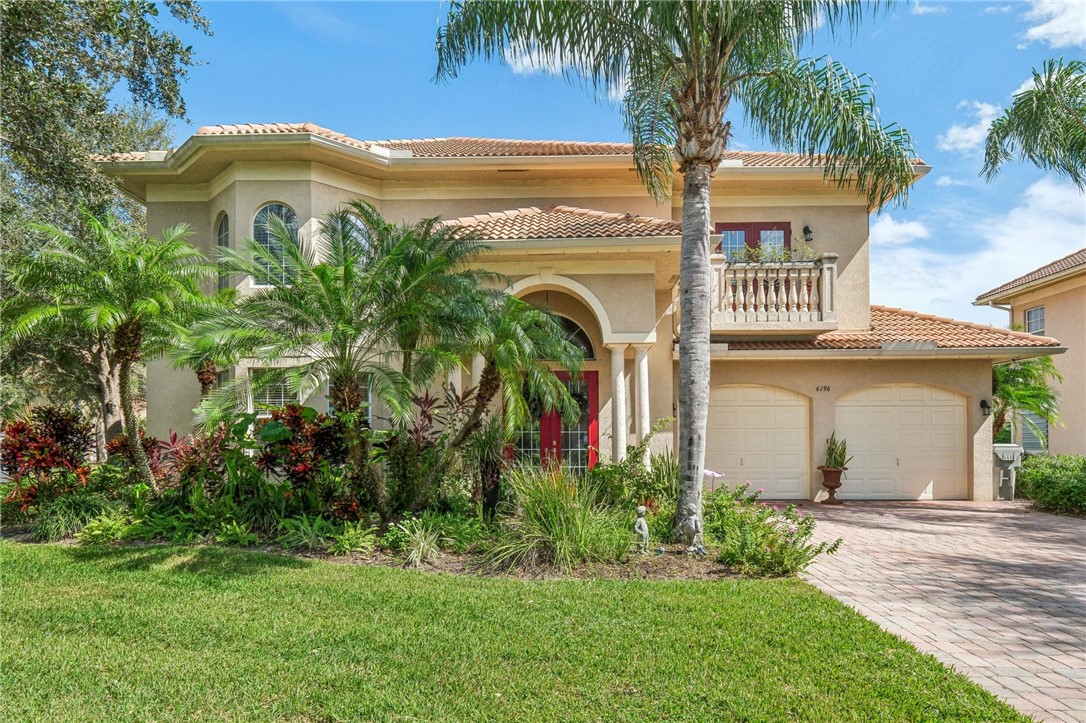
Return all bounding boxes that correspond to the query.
[973,249,1086,455]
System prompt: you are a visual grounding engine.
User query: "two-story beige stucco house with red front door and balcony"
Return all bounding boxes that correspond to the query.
[102,124,1061,499]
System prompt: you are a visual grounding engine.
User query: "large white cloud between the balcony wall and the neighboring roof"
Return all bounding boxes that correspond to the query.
[871,178,1086,326]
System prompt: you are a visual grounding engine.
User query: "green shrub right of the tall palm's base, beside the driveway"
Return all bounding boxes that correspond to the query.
[704,484,842,576]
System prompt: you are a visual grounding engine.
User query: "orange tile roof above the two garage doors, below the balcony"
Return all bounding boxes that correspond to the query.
[728,306,1059,351]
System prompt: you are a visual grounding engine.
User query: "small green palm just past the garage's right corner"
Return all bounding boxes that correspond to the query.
[992,356,1063,440]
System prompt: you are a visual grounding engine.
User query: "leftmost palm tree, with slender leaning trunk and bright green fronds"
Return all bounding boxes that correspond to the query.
[10,212,214,491]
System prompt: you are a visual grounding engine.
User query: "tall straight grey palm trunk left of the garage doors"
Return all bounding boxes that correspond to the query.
[675,163,712,524]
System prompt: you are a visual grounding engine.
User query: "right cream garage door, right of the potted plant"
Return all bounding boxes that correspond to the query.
[836,384,967,499]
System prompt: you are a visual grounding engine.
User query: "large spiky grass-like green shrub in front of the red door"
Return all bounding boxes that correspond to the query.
[487,467,632,569]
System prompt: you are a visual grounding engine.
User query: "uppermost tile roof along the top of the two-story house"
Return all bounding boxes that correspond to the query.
[94,123,923,168]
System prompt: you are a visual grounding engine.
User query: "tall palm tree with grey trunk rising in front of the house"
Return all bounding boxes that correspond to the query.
[437,0,914,529]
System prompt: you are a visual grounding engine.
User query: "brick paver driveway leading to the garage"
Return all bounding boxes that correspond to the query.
[803,502,1086,723]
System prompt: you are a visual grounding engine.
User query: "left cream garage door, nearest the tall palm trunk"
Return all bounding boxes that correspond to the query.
[705,386,810,499]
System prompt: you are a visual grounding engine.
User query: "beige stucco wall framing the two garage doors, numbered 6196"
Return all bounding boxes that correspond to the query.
[674,358,994,500]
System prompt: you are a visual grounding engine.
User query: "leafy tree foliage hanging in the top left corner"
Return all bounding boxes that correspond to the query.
[0,0,210,198]
